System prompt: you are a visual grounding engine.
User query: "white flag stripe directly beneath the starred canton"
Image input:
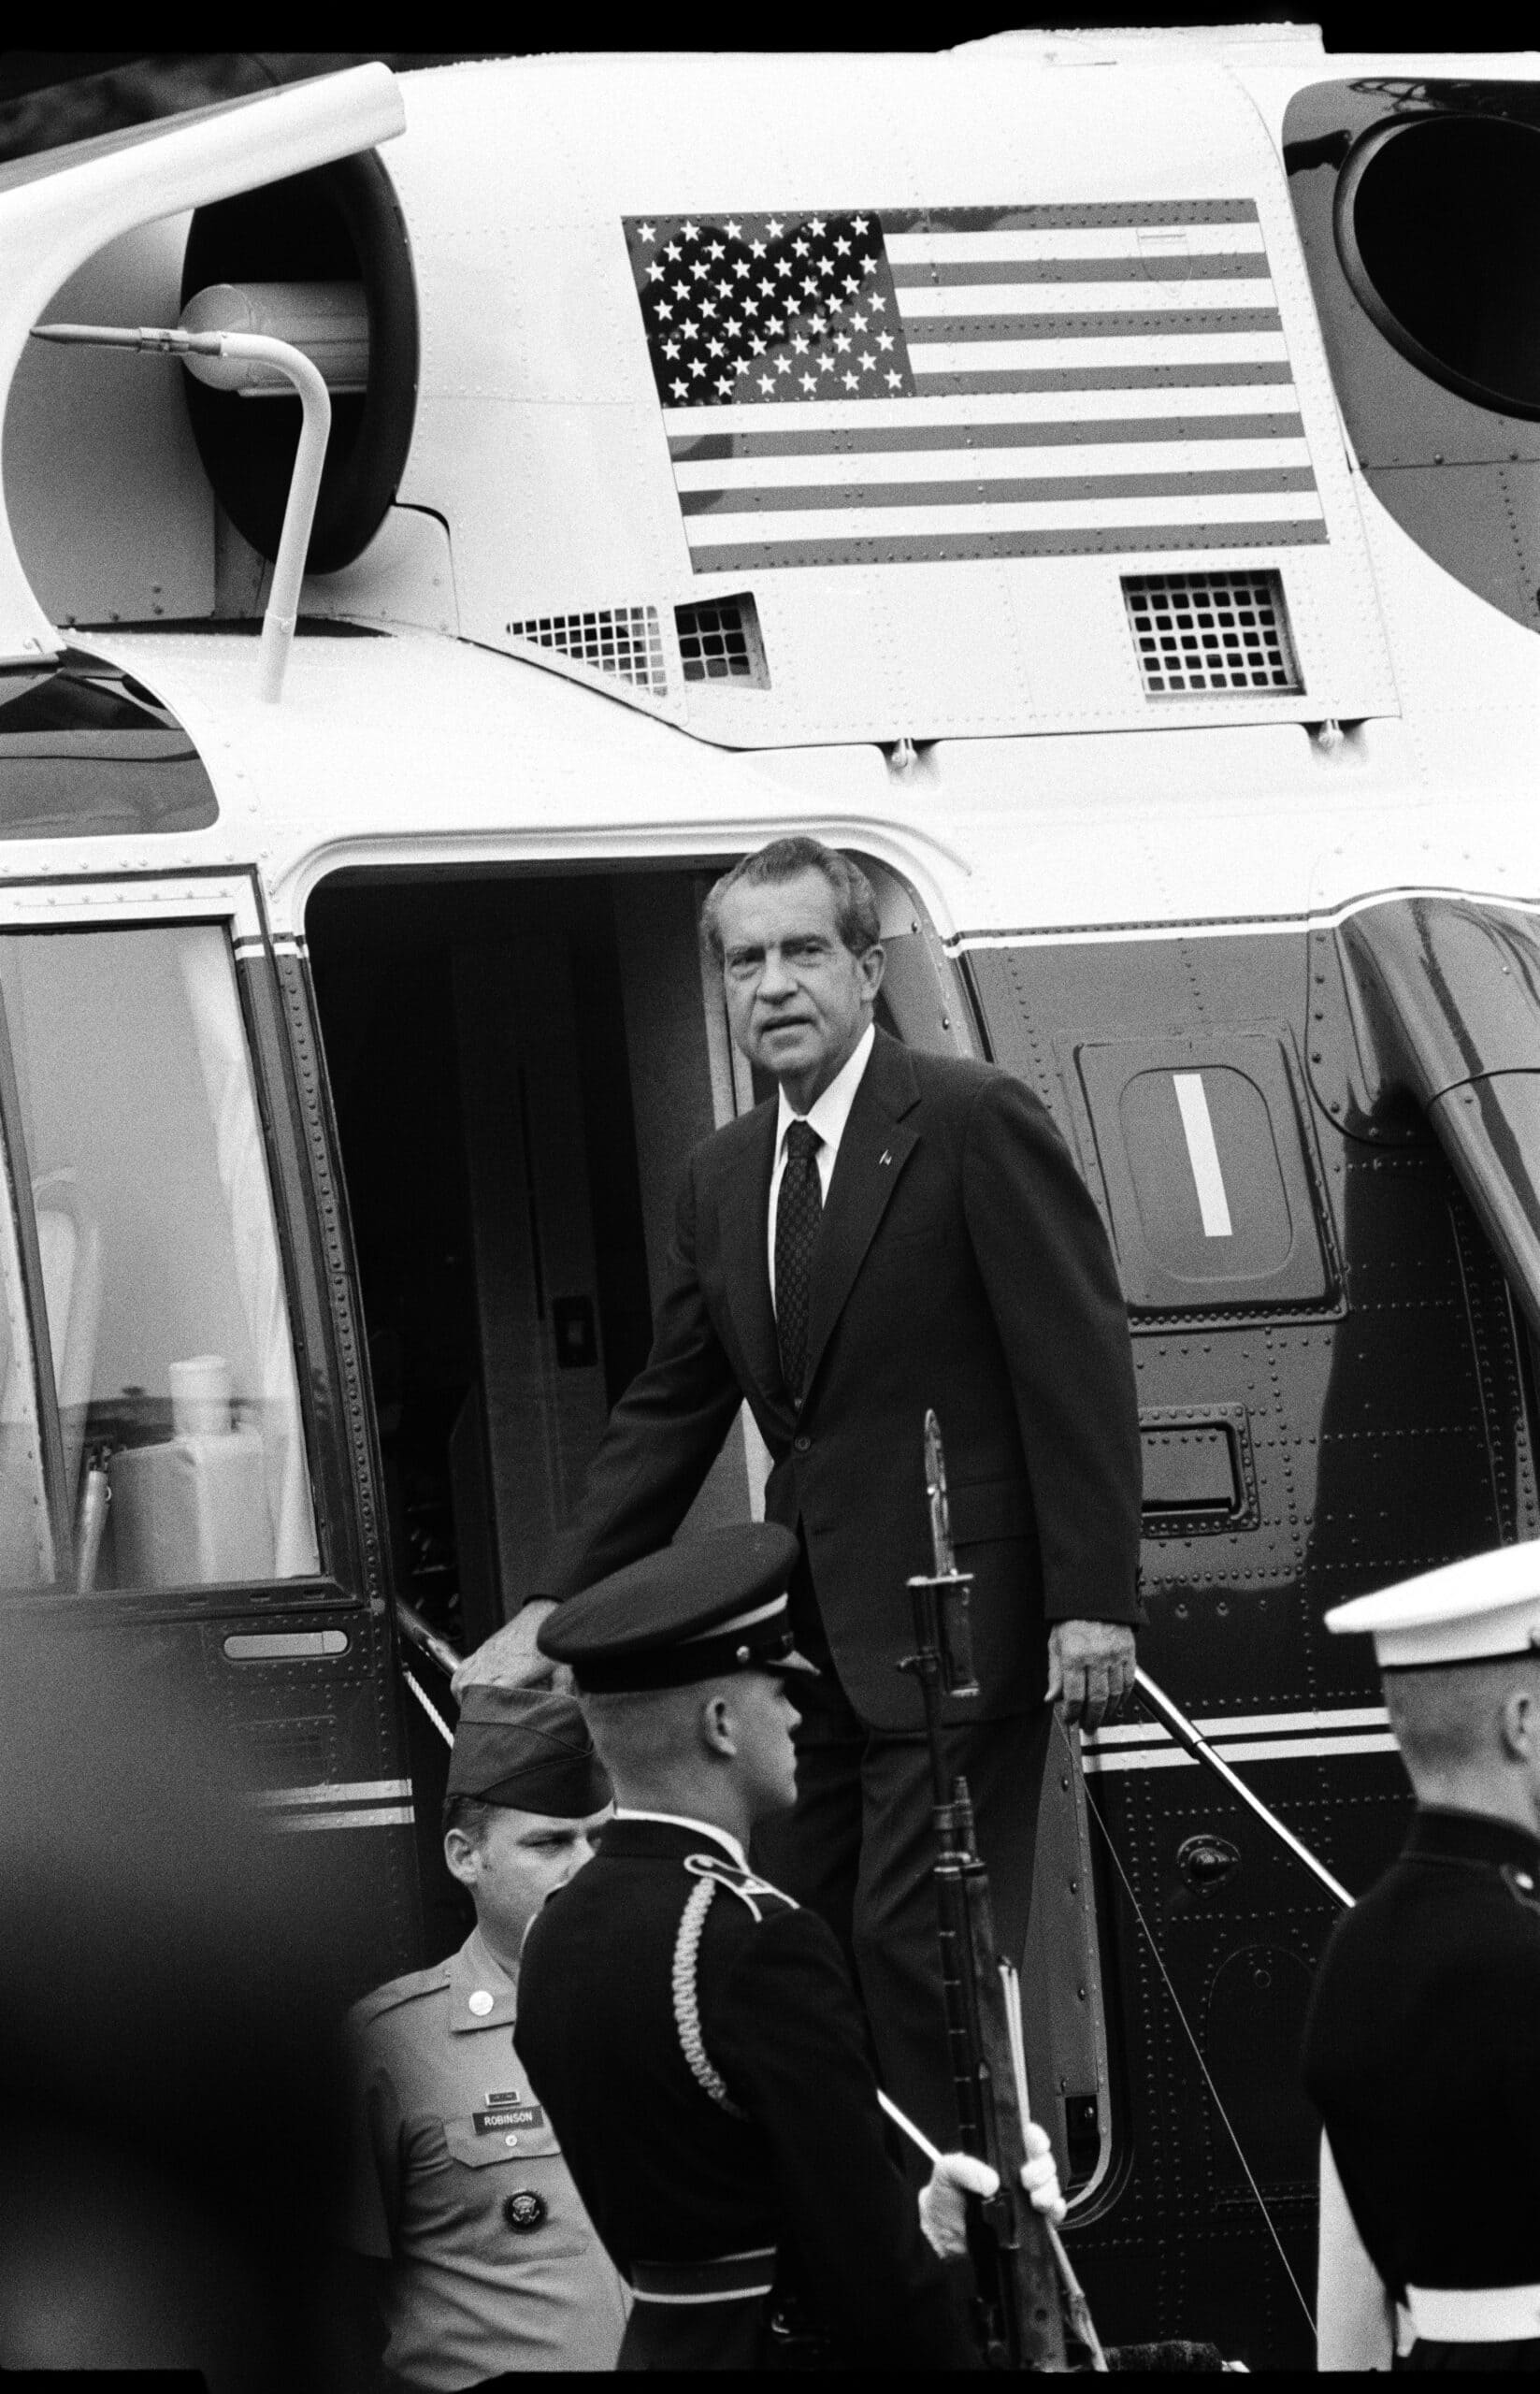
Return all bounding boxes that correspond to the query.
[664,383,1301,440]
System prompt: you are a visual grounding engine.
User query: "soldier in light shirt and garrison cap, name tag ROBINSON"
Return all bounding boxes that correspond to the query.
[342,1688,626,2394]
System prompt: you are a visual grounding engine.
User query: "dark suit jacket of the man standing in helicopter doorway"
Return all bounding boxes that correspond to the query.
[543,1031,1140,1728]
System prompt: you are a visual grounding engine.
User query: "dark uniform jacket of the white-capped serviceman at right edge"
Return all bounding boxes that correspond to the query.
[1305,1810,1540,2368]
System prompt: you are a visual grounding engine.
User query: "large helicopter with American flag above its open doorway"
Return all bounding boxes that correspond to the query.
[0,26,1540,2368]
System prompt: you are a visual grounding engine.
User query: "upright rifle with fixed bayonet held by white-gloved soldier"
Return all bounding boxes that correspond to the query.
[900,1412,1106,2370]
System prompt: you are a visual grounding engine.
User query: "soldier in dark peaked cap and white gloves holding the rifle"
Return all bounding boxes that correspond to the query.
[520,1522,1063,2370]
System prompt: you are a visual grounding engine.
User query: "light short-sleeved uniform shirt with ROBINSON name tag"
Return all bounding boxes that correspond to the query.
[342,1929,627,2394]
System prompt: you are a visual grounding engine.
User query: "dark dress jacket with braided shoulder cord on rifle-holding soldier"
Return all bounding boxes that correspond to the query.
[520,1820,972,2370]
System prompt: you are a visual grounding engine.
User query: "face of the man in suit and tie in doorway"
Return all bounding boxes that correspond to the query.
[718,869,884,1106]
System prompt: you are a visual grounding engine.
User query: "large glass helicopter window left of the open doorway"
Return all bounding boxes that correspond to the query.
[0,924,319,1592]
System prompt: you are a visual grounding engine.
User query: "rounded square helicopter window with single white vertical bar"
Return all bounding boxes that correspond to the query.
[1080,1031,1331,1312]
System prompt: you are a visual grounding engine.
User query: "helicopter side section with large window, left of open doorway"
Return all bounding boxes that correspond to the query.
[0,876,414,1992]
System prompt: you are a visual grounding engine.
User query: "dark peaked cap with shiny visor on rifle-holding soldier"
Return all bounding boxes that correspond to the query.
[539,1521,812,1695]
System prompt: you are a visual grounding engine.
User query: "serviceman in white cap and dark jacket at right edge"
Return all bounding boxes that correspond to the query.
[1305,1544,1540,2370]
